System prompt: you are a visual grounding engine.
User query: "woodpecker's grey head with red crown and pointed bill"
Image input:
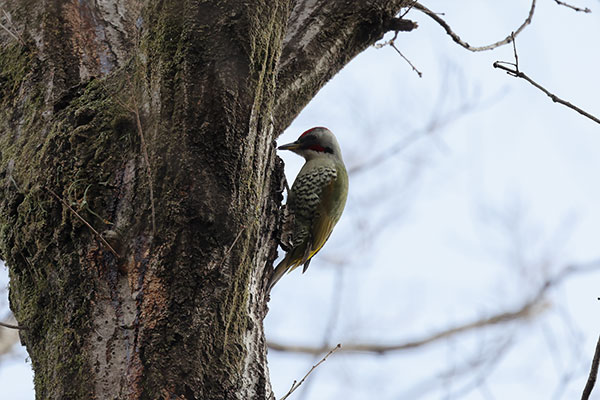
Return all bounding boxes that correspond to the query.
[278,126,342,161]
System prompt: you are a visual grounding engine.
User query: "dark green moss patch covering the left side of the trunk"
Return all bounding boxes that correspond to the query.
[0,45,138,399]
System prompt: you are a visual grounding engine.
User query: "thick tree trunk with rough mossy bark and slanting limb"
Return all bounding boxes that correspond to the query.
[0,0,414,399]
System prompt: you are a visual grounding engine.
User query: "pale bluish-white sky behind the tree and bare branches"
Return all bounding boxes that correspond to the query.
[0,0,600,400]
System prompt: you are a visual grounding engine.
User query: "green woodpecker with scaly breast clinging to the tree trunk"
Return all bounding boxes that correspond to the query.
[269,127,348,290]
